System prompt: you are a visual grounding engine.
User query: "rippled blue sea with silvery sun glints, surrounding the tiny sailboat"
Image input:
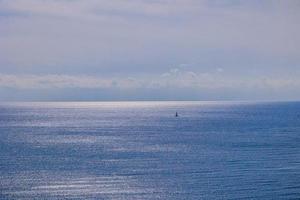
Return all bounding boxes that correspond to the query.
[0,102,300,200]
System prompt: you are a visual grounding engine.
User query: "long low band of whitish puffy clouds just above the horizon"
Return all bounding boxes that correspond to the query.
[0,70,300,91]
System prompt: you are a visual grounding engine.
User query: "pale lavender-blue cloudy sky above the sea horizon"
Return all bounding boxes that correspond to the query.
[0,0,300,101]
